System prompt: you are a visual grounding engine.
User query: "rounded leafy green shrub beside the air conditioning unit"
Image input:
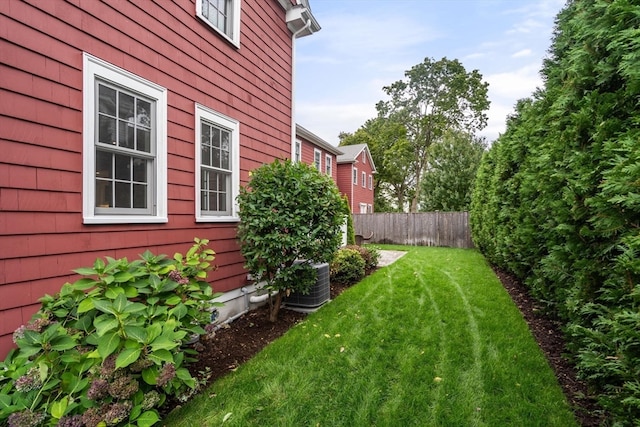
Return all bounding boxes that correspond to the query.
[238,160,348,322]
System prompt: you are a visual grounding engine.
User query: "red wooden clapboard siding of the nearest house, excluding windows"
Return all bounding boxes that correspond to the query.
[0,0,298,356]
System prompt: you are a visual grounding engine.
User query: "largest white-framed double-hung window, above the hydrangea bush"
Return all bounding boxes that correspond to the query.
[82,53,168,224]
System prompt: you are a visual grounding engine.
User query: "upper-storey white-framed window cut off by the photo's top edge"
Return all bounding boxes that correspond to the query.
[196,0,240,47]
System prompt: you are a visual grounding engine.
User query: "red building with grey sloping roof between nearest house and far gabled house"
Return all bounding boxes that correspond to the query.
[293,124,342,183]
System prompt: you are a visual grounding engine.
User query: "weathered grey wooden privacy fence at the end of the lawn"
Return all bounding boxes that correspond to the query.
[353,212,474,248]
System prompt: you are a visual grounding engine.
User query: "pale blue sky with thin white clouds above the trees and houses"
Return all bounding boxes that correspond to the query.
[295,0,565,145]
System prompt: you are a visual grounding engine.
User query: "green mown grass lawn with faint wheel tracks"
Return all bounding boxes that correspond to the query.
[163,246,577,427]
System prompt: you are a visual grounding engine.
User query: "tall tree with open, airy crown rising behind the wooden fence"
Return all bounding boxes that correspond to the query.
[376,58,489,212]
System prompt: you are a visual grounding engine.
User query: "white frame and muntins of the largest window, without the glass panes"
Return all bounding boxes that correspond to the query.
[82,52,168,224]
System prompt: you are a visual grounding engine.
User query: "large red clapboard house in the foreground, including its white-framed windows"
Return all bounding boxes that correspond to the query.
[0,0,320,357]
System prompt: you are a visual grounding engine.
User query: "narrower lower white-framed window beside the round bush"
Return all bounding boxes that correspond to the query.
[195,104,240,222]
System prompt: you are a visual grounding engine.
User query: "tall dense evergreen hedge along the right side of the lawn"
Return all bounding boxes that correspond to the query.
[471,0,640,425]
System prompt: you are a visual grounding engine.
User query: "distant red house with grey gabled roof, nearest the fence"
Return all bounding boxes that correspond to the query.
[338,144,376,214]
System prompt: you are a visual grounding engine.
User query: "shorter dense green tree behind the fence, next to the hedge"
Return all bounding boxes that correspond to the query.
[420,132,485,212]
